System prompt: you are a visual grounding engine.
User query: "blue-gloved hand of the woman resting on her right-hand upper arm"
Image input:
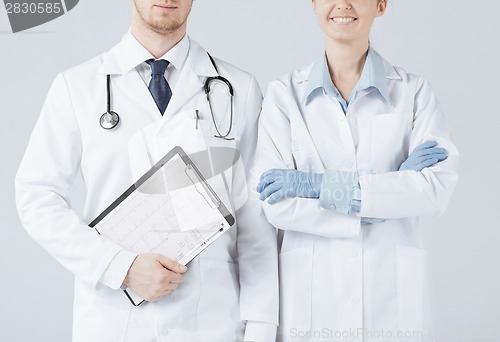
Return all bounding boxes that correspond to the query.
[399,141,447,172]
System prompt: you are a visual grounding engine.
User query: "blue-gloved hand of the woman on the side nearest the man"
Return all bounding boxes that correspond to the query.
[257,169,323,204]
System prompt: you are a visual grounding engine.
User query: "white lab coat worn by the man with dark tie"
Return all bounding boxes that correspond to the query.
[16,34,278,342]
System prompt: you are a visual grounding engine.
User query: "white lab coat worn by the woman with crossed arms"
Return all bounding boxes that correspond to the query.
[257,57,458,342]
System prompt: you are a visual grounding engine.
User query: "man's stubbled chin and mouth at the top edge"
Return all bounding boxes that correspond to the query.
[134,0,193,34]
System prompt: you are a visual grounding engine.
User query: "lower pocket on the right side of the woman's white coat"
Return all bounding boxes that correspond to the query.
[396,245,427,332]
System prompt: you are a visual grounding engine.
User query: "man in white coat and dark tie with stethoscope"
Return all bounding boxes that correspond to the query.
[16,0,278,342]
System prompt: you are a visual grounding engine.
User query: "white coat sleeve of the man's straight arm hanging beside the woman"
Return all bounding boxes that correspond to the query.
[233,77,279,341]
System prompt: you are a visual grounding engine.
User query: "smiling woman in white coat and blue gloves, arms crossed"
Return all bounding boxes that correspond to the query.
[257,0,458,341]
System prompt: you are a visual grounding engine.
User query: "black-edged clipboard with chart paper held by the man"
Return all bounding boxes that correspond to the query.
[89,146,235,306]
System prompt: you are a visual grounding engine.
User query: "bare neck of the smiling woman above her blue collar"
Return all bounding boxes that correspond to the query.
[326,40,369,80]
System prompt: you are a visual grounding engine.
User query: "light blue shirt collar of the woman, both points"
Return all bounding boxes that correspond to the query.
[303,47,391,104]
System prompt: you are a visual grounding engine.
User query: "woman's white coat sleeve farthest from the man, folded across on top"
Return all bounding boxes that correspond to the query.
[359,79,459,219]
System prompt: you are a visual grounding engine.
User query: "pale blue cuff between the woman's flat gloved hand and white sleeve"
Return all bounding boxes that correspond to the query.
[319,170,361,215]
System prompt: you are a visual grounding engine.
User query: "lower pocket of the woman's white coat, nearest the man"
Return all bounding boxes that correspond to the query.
[279,247,313,337]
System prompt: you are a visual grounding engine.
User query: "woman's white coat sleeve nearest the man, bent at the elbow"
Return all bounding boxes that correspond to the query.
[252,81,360,238]
